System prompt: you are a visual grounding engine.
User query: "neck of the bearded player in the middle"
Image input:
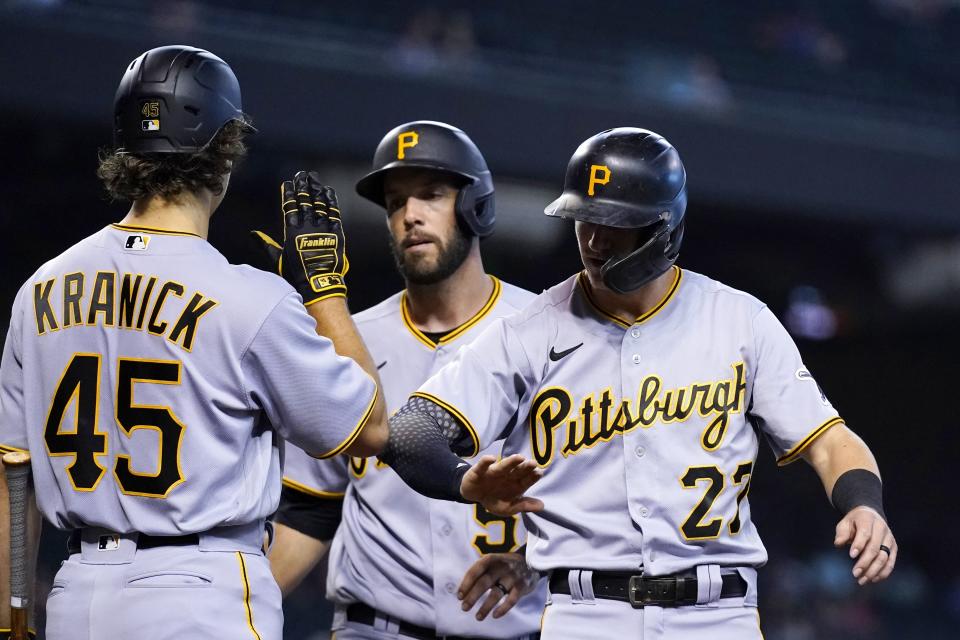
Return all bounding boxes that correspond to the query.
[407,245,493,333]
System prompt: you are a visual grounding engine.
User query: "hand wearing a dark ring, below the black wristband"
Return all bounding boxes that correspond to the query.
[833,507,897,586]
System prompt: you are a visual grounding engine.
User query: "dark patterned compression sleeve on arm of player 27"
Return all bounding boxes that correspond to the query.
[380,396,472,502]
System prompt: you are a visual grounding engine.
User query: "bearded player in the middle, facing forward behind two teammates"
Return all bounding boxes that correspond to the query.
[270,121,546,640]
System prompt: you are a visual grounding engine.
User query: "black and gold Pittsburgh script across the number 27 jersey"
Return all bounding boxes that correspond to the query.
[530,362,747,467]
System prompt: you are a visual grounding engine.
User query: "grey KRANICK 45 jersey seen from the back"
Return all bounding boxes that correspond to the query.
[0,225,377,535]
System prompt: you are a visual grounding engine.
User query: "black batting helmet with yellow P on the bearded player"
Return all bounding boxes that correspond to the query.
[357,120,495,238]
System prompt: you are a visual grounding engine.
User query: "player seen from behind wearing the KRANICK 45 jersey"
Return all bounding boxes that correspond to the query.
[0,46,386,640]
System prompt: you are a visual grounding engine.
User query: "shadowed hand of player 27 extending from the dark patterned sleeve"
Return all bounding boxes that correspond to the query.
[460,454,543,516]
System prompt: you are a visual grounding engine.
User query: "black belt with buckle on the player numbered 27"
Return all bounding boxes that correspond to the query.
[550,569,747,609]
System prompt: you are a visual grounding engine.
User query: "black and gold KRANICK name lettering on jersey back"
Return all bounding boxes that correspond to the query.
[33,271,219,351]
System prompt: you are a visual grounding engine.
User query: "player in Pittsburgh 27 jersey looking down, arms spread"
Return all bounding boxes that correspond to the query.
[383,128,897,640]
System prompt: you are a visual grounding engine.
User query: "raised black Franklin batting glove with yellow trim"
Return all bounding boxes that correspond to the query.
[253,171,350,305]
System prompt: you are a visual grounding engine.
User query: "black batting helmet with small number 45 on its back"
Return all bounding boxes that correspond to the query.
[113,45,252,153]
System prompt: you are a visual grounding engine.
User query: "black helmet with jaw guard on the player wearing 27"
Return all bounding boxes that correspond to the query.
[544,127,687,293]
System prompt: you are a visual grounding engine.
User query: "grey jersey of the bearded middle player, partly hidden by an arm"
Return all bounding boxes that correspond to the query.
[284,279,546,638]
